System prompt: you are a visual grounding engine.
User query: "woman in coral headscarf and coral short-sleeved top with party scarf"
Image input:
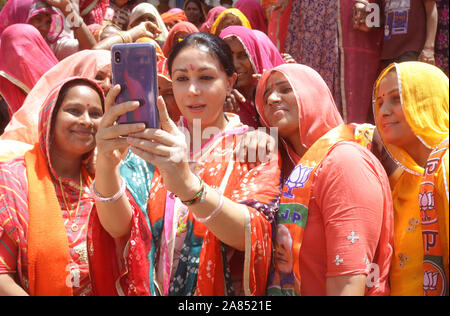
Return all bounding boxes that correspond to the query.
[256,64,393,295]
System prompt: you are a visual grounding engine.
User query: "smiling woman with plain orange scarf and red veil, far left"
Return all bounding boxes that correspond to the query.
[0,78,104,296]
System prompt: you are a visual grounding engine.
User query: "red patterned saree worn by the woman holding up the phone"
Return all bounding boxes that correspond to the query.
[92,114,280,295]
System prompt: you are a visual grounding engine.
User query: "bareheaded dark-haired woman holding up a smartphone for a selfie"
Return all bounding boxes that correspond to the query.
[90,33,280,295]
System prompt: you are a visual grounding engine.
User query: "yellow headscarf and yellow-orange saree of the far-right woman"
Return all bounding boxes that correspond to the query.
[373,62,449,296]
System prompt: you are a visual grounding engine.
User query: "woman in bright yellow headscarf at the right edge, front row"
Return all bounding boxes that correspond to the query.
[373,62,449,296]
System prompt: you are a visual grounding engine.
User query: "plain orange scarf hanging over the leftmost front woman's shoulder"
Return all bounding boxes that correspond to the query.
[25,144,89,296]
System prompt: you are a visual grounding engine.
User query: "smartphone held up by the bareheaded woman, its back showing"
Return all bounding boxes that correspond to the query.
[111,43,159,128]
